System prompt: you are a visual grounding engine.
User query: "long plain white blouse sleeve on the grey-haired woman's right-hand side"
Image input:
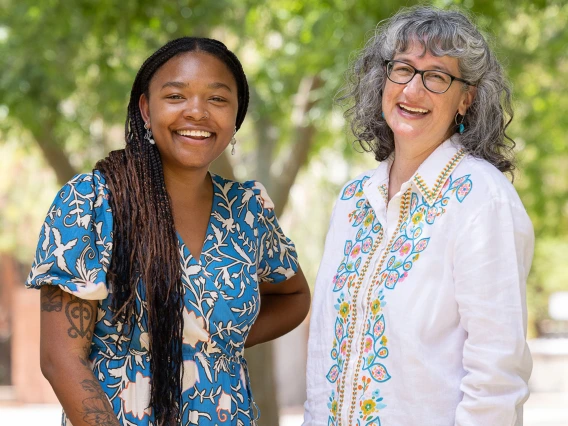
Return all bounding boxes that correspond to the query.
[454,195,534,426]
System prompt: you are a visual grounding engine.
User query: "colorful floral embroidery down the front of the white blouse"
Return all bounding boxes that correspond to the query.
[327,159,472,426]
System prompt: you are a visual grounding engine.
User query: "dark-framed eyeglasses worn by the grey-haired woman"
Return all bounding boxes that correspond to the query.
[385,60,475,93]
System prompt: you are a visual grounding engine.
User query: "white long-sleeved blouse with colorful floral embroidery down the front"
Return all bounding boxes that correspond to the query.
[304,136,534,426]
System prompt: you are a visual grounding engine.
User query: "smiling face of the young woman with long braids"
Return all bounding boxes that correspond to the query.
[139,51,238,170]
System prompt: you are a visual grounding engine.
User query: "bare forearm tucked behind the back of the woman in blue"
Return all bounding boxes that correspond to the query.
[245,292,310,347]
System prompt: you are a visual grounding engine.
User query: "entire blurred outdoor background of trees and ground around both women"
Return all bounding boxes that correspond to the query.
[0,0,568,426]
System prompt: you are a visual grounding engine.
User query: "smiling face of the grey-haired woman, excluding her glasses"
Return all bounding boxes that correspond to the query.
[382,42,474,154]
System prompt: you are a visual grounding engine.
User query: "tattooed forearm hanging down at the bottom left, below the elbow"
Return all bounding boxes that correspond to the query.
[44,356,120,426]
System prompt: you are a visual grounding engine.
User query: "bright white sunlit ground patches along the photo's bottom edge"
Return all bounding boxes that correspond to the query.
[0,393,568,426]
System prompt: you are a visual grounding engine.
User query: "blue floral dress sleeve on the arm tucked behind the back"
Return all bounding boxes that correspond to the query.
[245,181,298,284]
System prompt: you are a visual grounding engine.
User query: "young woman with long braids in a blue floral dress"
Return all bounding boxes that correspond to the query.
[27,37,310,426]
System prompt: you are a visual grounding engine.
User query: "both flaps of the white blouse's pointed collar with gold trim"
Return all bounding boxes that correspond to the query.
[364,135,465,206]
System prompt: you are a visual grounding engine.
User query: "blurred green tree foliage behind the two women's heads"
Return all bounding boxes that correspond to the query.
[0,0,568,230]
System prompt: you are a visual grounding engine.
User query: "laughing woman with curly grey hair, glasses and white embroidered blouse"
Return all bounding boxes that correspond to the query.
[304,7,534,426]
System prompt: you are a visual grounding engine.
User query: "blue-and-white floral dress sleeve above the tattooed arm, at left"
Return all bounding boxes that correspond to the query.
[26,172,112,300]
